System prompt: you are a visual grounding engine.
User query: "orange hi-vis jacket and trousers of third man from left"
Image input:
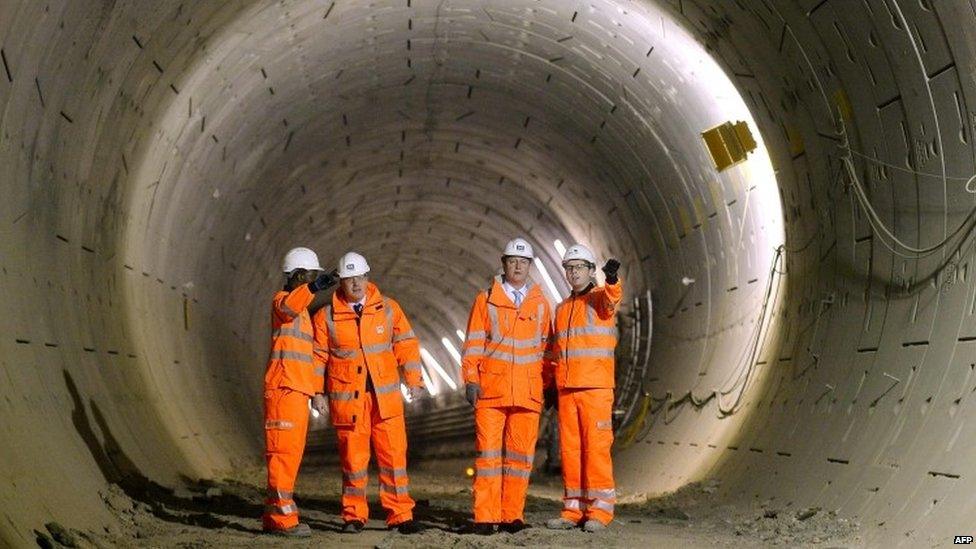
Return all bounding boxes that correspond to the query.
[461,279,552,523]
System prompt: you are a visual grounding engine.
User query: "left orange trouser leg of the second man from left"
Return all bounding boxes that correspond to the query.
[336,388,378,522]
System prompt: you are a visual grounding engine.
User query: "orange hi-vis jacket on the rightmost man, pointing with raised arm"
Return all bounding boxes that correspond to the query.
[546,280,623,389]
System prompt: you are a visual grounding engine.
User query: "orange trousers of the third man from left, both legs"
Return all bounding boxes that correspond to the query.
[474,406,539,523]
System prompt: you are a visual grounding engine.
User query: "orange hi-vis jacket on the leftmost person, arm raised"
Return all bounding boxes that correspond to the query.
[264,284,325,396]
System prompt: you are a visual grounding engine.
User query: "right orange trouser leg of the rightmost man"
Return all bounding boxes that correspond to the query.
[576,389,617,524]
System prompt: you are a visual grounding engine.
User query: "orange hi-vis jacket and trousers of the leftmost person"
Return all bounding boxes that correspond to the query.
[262,284,324,530]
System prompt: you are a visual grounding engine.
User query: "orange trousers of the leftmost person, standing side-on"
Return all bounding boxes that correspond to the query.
[262,387,309,530]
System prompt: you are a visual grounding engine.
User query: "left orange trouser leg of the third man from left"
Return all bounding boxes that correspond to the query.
[472,408,505,522]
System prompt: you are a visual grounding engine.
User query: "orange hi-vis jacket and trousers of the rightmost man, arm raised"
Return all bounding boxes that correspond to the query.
[546,280,623,524]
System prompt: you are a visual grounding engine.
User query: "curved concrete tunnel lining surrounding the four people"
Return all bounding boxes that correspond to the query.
[0,0,976,546]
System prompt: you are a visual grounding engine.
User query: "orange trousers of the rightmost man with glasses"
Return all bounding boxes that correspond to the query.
[559,389,617,524]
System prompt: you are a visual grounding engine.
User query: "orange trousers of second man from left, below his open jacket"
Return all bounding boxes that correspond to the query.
[336,389,414,526]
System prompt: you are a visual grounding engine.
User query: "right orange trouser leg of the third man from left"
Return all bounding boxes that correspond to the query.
[502,408,539,522]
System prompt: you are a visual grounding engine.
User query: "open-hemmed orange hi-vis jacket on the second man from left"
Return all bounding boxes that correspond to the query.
[314,282,423,426]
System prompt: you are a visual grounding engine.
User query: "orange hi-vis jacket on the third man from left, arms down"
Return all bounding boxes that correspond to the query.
[461,279,552,411]
